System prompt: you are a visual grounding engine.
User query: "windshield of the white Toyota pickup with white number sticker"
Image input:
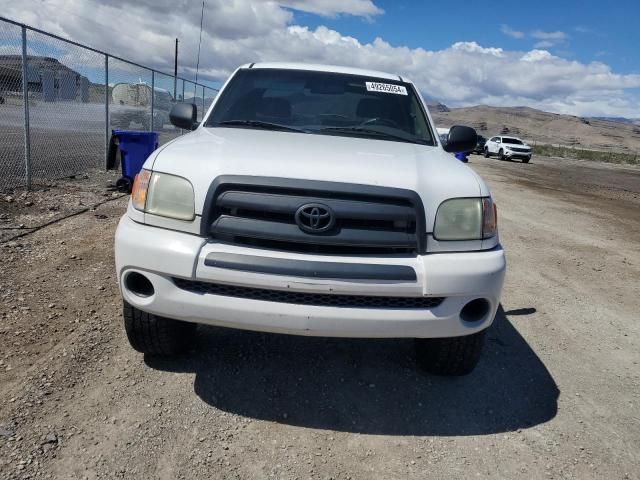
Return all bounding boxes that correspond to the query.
[204,68,435,145]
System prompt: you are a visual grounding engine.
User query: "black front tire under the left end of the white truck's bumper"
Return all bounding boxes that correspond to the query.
[122,302,196,355]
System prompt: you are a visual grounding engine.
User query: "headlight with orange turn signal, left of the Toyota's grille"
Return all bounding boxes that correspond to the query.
[131,170,195,220]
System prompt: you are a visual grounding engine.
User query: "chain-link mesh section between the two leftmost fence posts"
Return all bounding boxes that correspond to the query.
[27,31,105,182]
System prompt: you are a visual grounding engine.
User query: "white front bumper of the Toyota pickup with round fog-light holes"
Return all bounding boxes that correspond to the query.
[115,215,505,337]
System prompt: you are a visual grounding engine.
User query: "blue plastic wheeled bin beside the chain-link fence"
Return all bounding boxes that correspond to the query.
[111,130,158,192]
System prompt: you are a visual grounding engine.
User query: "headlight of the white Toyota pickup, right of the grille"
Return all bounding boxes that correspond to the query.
[433,197,498,240]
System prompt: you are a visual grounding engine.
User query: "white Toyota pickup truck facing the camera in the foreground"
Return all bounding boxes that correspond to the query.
[115,64,505,375]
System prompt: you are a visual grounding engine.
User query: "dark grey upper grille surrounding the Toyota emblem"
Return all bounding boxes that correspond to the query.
[201,176,426,255]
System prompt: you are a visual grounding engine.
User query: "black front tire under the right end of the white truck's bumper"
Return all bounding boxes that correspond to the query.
[415,330,485,376]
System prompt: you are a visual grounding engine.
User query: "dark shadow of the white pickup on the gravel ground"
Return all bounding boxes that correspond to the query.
[145,307,559,436]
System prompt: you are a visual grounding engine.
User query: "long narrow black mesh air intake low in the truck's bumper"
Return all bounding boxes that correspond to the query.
[173,278,444,310]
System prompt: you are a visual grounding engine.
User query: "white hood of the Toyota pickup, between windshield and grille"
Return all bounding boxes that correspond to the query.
[150,127,489,231]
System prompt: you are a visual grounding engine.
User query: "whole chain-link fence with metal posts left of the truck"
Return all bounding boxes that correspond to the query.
[0,17,217,191]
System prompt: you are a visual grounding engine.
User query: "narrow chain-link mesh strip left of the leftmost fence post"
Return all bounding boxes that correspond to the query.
[0,22,26,188]
